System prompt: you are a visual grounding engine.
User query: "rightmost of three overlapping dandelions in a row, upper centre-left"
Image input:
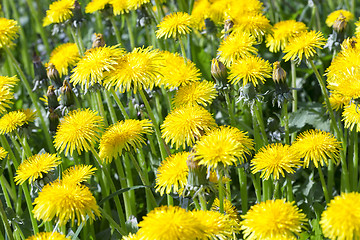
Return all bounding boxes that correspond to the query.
[158,51,200,88]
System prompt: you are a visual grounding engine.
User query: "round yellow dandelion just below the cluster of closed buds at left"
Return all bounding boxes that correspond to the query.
[54,109,103,156]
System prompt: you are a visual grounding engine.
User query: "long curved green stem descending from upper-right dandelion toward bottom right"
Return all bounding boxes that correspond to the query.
[308,59,350,192]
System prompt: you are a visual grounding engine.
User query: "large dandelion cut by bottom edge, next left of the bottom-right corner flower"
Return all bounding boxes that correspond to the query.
[241,199,307,240]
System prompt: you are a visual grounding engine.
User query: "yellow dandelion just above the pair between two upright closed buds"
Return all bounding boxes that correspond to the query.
[230,12,272,41]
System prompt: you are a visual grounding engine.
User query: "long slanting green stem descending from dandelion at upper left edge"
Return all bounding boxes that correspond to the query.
[4,46,55,153]
